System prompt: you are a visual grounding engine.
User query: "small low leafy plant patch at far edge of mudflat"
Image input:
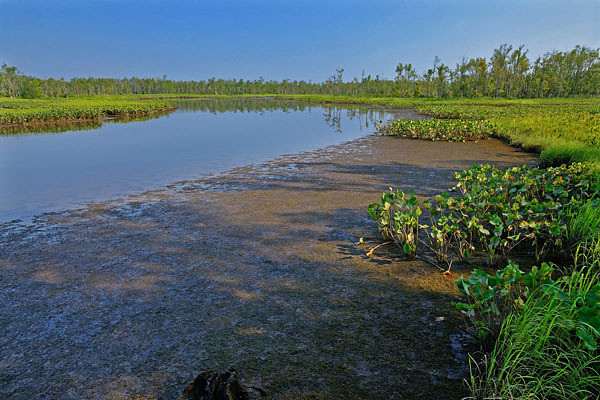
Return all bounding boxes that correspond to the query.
[378,119,496,142]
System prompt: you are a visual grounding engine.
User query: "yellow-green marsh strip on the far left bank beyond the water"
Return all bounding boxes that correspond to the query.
[0,97,174,125]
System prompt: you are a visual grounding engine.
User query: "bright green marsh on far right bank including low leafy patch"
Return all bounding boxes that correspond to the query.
[370,99,600,152]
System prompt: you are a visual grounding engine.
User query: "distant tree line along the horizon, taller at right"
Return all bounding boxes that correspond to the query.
[0,44,600,98]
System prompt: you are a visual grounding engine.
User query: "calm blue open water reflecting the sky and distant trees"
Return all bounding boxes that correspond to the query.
[0,100,398,222]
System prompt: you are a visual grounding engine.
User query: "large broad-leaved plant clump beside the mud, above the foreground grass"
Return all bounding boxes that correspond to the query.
[368,163,600,266]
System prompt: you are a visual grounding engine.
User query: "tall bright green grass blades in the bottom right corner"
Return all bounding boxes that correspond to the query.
[469,265,600,400]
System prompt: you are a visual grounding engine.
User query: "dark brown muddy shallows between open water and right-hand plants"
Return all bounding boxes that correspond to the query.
[0,135,533,399]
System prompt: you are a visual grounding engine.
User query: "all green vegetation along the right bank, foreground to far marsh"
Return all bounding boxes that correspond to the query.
[369,99,600,399]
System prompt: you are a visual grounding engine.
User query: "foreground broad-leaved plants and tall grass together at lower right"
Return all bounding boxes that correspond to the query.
[368,159,600,399]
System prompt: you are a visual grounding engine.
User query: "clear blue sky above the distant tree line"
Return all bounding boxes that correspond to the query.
[0,0,600,81]
